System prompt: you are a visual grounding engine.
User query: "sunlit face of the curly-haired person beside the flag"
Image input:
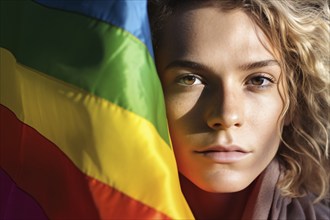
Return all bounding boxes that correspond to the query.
[156,7,283,192]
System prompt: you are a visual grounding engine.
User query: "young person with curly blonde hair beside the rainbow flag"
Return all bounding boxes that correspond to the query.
[149,0,330,219]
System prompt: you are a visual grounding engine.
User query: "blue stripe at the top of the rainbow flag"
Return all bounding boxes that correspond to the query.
[35,0,153,56]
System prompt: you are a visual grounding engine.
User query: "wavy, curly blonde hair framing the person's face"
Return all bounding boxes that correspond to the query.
[149,0,330,202]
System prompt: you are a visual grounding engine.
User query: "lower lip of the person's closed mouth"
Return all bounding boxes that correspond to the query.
[198,151,250,163]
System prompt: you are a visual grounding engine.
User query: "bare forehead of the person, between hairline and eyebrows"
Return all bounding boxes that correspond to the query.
[156,6,274,71]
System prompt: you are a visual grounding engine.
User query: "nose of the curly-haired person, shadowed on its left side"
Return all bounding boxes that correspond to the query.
[207,89,244,130]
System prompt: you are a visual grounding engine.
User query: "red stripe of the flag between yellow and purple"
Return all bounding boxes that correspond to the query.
[0,105,169,219]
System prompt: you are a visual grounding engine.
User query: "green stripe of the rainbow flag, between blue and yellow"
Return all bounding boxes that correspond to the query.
[0,1,170,144]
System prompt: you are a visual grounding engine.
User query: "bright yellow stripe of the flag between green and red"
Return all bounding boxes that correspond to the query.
[0,49,193,219]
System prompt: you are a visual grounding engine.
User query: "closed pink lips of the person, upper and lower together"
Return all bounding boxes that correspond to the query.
[195,145,251,163]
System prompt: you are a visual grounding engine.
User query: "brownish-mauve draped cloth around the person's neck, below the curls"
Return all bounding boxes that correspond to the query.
[242,159,330,220]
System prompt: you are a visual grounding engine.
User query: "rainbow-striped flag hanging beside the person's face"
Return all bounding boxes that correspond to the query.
[0,0,193,219]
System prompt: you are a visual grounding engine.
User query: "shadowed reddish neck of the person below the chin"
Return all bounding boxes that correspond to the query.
[180,174,254,219]
